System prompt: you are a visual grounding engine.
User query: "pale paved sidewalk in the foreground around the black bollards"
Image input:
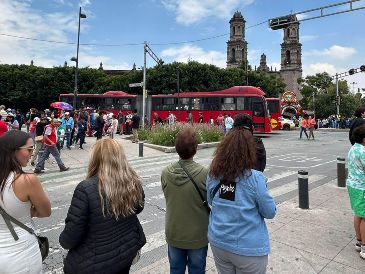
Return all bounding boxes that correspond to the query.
[134,180,365,274]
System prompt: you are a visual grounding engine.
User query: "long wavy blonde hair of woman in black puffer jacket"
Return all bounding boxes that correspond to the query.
[87,139,144,219]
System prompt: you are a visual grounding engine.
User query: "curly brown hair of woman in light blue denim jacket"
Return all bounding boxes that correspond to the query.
[210,128,256,181]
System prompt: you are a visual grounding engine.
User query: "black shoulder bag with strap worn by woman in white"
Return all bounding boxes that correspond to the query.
[0,206,49,261]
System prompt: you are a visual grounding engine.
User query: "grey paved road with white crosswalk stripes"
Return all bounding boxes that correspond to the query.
[36,131,350,273]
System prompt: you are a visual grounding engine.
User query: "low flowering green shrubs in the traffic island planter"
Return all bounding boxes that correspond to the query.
[138,123,224,146]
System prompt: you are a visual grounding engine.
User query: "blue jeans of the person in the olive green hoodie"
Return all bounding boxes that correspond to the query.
[168,245,208,274]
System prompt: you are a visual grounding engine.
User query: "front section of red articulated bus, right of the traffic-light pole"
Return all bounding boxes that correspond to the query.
[151,86,271,133]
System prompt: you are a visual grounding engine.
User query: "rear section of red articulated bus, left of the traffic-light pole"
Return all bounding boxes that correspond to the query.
[60,91,138,115]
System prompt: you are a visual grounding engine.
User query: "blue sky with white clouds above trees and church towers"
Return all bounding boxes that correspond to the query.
[0,0,365,90]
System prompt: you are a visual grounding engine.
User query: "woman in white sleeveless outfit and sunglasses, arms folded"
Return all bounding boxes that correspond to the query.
[0,130,51,274]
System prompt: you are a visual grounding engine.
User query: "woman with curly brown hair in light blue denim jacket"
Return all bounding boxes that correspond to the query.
[207,126,276,274]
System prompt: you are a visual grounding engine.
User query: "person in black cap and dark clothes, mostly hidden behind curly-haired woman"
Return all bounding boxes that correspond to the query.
[233,114,266,172]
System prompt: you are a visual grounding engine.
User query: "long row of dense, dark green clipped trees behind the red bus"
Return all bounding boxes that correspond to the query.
[0,61,285,110]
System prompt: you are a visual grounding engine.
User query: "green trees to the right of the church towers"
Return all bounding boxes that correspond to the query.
[299,72,361,118]
